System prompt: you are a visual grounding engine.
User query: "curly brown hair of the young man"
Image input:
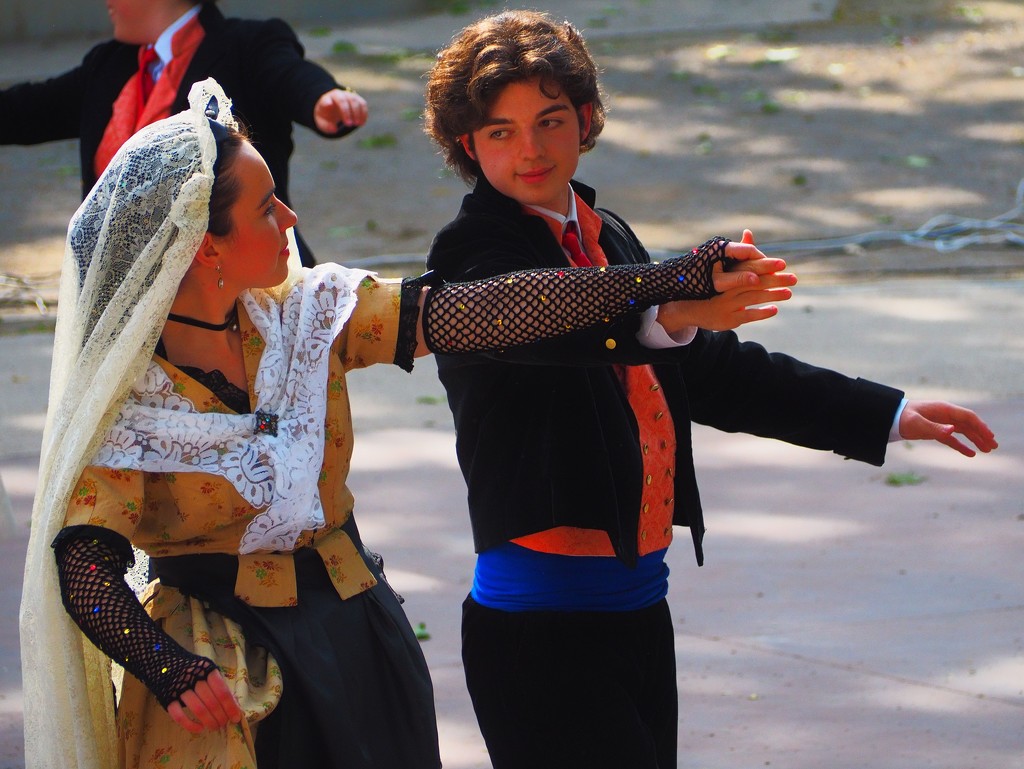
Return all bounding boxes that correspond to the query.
[424,10,605,183]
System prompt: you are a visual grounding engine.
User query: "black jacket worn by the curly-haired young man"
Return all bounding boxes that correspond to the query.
[427,177,902,565]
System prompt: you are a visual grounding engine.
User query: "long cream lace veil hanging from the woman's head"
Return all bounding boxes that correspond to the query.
[20,80,234,769]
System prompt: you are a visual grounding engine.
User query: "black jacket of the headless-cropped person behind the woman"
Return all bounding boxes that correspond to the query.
[0,3,352,263]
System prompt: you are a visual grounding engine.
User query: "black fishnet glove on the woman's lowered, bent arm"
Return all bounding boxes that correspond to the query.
[53,526,217,709]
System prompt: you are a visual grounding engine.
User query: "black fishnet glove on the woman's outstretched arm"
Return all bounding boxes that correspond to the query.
[423,238,732,352]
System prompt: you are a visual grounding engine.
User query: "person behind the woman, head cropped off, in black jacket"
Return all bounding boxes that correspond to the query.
[0,0,368,266]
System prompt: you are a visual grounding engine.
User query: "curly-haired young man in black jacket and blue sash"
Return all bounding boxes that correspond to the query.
[425,11,996,769]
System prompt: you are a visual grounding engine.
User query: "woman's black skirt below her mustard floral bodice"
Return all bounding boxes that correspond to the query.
[154,519,440,769]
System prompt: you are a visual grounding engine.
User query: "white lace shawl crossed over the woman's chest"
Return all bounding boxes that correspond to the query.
[93,264,369,553]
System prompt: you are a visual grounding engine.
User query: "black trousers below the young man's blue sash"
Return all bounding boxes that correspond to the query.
[462,598,679,769]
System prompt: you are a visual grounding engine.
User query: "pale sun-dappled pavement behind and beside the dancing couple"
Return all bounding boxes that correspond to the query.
[0,3,1024,769]
